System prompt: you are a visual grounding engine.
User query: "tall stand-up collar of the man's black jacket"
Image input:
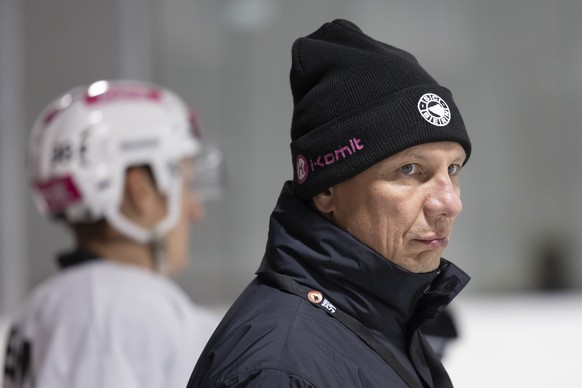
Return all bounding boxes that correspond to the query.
[261,182,469,345]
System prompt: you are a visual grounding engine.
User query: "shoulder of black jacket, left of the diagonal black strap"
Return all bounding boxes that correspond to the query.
[188,280,406,388]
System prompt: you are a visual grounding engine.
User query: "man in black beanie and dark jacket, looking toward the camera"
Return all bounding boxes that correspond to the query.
[188,20,471,388]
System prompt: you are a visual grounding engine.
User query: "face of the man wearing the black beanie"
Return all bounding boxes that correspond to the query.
[314,142,465,273]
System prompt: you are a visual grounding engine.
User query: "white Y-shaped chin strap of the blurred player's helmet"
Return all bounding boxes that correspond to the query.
[105,179,182,274]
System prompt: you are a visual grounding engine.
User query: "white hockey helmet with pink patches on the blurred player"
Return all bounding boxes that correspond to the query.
[29,80,210,243]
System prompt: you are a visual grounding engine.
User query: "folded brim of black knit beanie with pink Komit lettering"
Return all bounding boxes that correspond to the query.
[291,84,471,200]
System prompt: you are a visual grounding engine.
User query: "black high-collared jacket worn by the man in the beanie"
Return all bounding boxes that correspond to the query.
[188,184,469,388]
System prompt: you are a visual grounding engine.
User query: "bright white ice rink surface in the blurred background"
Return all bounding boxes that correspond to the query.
[0,293,582,388]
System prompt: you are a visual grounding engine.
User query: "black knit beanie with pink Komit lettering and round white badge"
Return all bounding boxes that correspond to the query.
[290,19,471,200]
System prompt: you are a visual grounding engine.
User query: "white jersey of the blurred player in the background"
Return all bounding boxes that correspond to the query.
[3,260,219,388]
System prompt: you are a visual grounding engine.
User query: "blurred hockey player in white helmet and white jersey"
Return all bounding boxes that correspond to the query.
[3,81,226,388]
